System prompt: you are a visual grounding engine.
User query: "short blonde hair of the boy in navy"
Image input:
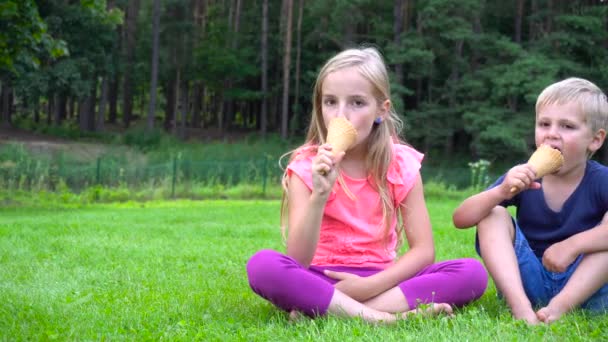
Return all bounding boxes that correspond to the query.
[536,77,608,134]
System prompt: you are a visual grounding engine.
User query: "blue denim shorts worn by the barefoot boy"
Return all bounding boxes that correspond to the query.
[475,220,608,312]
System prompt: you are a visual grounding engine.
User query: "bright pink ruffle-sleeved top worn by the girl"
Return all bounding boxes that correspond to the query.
[287,144,424,269]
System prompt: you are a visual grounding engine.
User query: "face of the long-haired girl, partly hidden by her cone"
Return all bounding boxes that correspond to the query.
[321,67,390,147]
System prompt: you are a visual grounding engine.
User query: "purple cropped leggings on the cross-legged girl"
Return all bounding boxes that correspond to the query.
[247,250,488,317]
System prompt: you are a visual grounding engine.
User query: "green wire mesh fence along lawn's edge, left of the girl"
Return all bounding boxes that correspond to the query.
[0,155,283,196]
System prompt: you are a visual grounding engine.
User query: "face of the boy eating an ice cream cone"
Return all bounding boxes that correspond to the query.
[535,102,603,170]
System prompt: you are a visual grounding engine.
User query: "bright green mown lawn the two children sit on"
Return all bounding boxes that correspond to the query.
[0,196,608,341]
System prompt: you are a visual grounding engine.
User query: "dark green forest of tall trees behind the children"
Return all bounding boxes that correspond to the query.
[0,0,608,198]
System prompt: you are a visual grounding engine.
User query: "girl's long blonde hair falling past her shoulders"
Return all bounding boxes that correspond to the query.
[281,47,403,247]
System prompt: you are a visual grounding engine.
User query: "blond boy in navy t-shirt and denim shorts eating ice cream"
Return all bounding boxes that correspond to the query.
[453,78,608,324]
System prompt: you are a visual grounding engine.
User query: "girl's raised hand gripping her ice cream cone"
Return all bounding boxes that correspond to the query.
[312,144,344,197]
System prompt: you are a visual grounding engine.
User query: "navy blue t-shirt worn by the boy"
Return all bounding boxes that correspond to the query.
[488,161,608,258]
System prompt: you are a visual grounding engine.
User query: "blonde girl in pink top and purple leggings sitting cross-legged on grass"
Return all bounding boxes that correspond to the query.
[247,48,487,322]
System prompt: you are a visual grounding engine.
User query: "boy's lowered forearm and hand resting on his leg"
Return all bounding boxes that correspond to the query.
[543,212,608,272]
